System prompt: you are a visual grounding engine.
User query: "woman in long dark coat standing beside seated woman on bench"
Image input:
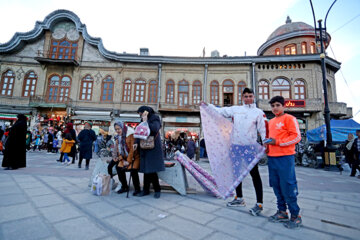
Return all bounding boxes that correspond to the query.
[136,106,165,198]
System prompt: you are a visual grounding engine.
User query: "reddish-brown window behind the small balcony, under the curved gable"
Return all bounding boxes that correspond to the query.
[50,39,78,59]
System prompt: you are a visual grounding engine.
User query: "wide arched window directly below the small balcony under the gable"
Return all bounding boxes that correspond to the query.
[47,75,71,102]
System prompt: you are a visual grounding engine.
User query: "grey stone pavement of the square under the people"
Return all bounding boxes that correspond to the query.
[0,152,360,240]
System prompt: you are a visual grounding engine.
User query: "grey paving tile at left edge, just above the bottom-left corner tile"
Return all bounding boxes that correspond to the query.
[0,203,37,223]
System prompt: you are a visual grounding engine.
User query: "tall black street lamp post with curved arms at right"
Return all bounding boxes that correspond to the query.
[309,0,336,150]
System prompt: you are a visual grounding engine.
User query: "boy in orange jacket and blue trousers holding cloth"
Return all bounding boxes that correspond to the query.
[267,96,302,228]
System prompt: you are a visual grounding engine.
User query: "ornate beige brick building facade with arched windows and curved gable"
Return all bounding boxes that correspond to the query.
[0,10,352,133]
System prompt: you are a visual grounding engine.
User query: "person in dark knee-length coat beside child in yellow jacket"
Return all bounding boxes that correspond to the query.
[78,122,96,170]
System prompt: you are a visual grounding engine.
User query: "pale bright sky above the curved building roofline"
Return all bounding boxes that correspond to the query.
[0,0,360,123]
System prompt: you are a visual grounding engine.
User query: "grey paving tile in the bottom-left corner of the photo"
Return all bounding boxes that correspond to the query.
[0,217,52,240]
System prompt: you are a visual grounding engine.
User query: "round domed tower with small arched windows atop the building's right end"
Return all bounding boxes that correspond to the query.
[257,16,331,56]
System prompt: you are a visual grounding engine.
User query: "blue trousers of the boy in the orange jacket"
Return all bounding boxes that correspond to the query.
[268,155,300,217]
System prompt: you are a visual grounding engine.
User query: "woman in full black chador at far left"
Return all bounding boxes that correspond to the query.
[2,114,27,170]
